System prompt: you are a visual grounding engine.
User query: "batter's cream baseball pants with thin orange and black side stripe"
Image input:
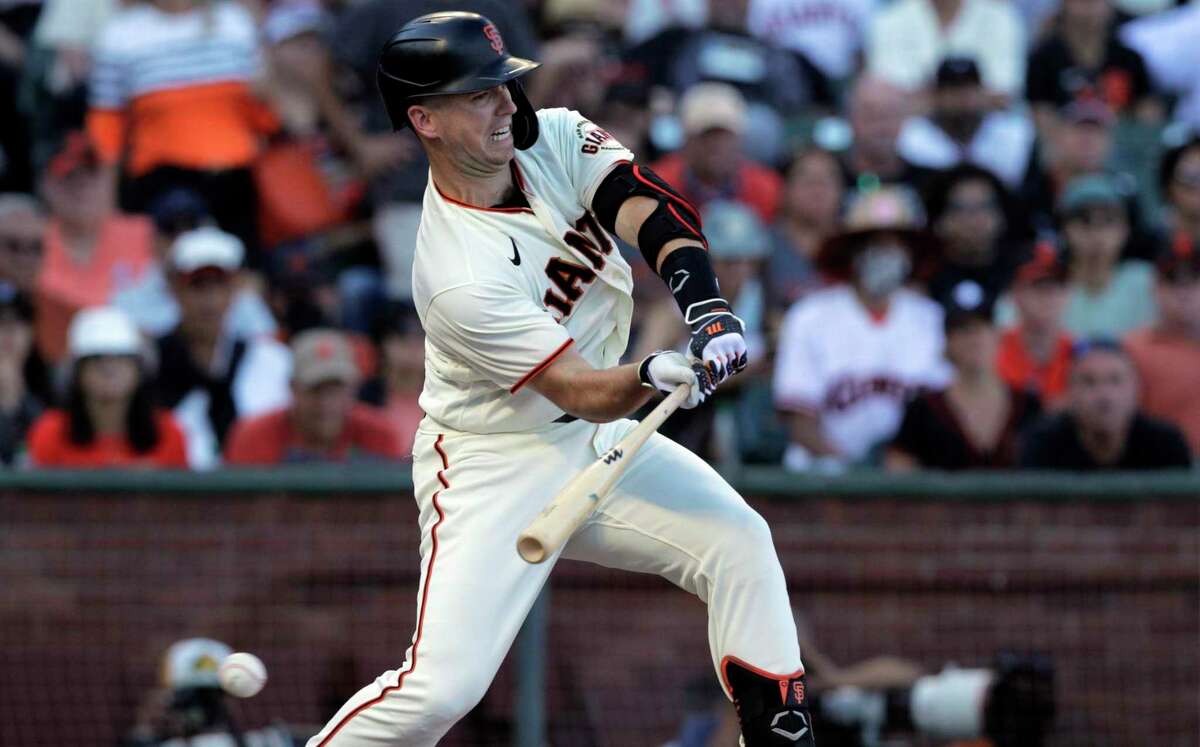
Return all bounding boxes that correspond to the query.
[307,420,802,747]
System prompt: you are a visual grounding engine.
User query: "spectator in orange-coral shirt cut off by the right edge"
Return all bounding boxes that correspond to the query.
[1126,233,1200,454]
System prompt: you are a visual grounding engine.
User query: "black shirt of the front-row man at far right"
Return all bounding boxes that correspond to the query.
[1021,413,1192,471]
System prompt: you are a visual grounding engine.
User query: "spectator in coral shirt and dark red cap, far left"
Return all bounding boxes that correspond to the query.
[35,132,155,360]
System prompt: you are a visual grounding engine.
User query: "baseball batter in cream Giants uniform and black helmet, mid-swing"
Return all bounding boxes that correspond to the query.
[308,12,814,747]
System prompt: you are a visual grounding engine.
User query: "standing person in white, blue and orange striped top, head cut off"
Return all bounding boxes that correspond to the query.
[88,0,278,257]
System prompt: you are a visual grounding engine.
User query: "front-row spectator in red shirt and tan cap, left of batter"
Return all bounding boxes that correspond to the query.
[226,329,402,465]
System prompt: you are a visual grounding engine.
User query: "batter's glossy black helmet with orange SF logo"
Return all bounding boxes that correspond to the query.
[376,11,540,150]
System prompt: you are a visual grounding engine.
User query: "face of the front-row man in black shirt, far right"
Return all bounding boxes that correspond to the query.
[1070,351,1138,431]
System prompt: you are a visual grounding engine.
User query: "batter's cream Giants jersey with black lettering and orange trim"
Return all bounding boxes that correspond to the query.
[413,109,634,434]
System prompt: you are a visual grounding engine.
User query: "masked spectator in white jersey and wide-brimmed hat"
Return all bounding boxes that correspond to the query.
[774,187,949,471]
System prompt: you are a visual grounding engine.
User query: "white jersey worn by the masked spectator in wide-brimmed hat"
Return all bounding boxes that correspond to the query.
[774,285,950,460]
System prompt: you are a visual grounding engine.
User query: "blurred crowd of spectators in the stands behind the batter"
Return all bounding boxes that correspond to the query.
[0,0,1200,473]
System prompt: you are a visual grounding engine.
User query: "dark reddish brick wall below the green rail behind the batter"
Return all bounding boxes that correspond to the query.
[0,492,1200,747]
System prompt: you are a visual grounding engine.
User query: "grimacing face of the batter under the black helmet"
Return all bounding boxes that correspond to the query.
[434,85,517,175]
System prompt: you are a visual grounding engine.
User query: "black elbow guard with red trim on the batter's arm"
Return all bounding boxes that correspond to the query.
[592,162,708,268]
